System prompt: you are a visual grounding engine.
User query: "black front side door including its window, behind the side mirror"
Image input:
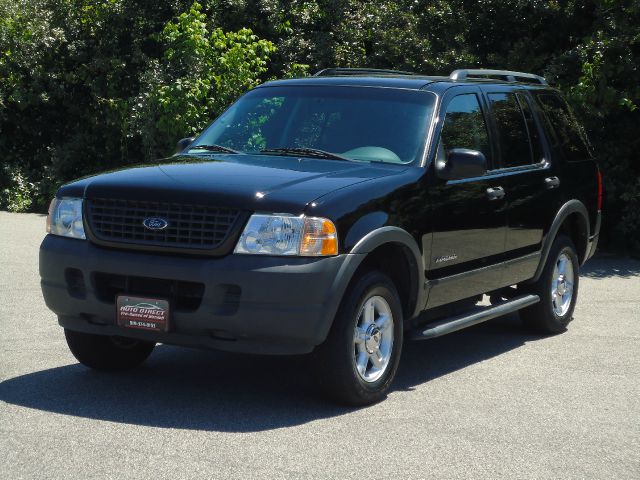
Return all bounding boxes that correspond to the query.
[425,87,507,308]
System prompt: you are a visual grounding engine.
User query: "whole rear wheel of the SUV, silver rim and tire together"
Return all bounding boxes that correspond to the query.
[520,234,580,333]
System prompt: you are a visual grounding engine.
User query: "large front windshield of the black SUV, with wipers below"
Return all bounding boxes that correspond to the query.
[189,86,435,164]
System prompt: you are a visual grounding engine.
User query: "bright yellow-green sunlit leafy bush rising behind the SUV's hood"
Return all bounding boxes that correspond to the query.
[134,3,275,158]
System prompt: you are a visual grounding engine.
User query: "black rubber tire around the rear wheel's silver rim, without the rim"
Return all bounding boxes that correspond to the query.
[520,234,580,334]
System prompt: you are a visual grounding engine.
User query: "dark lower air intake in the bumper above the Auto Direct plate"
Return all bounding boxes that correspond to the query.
[93,272,204,312]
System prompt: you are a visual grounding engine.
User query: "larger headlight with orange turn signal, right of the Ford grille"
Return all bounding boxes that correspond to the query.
[234,214,338,257]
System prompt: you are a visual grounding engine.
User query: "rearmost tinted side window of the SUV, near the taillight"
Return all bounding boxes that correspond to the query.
[536,93,589,161]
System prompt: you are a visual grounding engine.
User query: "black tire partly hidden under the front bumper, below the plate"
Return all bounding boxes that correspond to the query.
[64,328,156,370]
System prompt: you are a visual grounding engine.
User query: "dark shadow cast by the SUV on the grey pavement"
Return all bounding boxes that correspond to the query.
[0,316,541,432]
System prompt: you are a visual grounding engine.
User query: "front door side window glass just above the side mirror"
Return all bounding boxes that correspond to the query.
[438,93,490,161]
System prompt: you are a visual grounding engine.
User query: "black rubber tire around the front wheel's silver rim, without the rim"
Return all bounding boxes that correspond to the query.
[313,272,403,406]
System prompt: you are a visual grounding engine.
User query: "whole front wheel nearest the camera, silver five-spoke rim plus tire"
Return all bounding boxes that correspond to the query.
[314,272,403,406]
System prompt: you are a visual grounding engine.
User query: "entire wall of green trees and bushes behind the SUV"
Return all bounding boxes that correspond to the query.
[0,0,640,253]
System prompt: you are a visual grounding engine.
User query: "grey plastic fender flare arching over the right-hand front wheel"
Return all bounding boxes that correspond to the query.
[322,226,426,344]
